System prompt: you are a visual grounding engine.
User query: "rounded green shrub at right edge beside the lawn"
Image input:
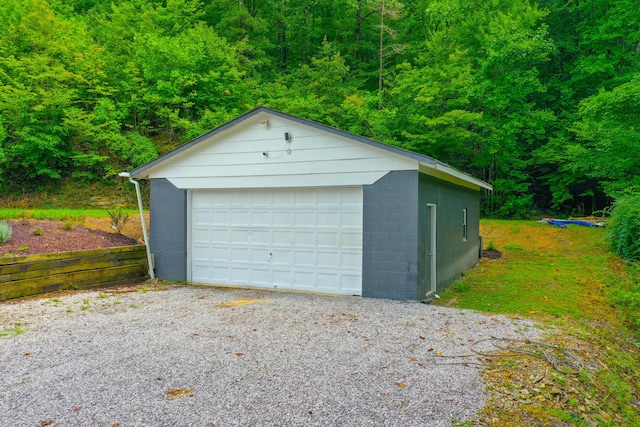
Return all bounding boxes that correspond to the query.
[608,193,640,261]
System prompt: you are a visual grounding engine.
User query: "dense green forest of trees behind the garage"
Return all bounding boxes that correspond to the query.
[0,0,640,217]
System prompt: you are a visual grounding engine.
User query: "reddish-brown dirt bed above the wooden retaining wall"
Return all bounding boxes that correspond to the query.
[0,216,148,256]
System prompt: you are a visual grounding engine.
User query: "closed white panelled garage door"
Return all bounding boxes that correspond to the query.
[191,187,362,295]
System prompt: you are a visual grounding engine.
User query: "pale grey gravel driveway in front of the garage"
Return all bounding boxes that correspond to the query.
[0,286,541,427]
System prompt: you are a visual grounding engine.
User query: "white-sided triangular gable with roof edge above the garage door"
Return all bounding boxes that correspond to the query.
[131,107,492,190]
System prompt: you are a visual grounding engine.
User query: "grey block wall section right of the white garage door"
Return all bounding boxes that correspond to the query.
[362,171,419,300]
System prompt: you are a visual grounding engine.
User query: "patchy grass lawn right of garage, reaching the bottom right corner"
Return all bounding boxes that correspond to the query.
[438,220,640,426]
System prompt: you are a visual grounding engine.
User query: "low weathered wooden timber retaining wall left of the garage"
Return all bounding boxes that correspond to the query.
[0,245,149,301]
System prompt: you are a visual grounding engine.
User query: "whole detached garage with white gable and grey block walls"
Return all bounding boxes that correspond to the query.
[129,107,491,300]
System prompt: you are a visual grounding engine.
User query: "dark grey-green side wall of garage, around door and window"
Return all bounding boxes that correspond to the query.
[418,174,480,300]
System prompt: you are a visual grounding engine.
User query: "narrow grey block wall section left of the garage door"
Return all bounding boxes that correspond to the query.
[149,178,187,281]
